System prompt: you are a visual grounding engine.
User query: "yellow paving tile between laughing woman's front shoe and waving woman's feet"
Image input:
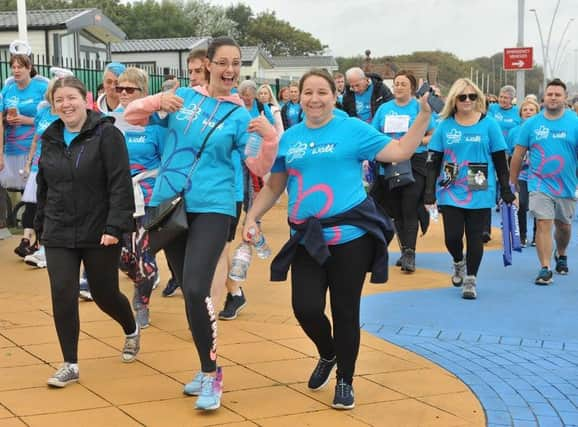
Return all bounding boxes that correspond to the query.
[222,386,327,420]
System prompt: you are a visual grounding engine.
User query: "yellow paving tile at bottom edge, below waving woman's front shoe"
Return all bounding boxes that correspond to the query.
[259,409,367,427]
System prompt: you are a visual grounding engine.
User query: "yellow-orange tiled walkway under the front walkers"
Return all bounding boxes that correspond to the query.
[0,205,482,427]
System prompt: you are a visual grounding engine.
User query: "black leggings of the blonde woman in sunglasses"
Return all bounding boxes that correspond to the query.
[441,205,491,276]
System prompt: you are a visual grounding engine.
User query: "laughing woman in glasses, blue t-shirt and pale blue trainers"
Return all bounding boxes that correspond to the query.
[124,37,278,410]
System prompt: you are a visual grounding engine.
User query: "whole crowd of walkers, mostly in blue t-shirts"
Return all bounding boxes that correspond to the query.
[0,37,578,410]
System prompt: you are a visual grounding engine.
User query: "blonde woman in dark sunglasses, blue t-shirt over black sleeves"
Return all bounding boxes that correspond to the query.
[424,79,515,299]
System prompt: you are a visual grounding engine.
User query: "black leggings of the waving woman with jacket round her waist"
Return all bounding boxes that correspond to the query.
[291,234,374,384]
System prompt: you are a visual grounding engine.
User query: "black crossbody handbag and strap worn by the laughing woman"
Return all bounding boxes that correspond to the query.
[143,106,239,253]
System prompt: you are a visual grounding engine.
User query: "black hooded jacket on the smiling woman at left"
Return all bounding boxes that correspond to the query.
[34,110,134,248]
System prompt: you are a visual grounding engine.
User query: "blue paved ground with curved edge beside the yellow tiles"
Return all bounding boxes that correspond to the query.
[361,215,578,427]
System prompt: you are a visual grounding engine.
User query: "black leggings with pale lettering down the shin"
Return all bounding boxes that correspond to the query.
[165,213,228,373]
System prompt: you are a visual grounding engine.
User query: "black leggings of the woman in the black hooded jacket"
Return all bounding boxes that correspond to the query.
[46,245,136,363]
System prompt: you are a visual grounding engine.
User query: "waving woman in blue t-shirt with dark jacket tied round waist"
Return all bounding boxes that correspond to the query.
[243,70,431,409]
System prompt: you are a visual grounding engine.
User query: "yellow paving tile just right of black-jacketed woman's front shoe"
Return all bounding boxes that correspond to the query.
[79,355,158,384]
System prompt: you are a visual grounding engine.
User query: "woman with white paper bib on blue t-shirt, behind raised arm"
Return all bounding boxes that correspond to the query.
[372,70,433,273]
